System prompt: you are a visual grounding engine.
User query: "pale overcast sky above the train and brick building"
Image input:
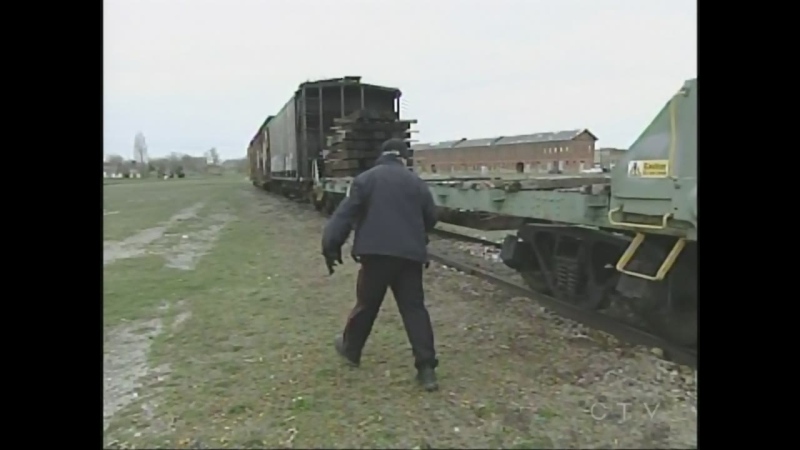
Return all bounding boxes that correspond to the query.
[104,0,697,159]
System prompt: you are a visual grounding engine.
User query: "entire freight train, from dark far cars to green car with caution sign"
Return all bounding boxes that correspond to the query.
[248,77,698,348]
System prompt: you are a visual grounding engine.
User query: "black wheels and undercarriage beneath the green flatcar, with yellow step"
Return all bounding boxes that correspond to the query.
[501,223,697,348]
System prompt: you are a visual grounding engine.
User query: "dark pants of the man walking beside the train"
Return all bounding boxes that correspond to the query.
[343,255,438,369]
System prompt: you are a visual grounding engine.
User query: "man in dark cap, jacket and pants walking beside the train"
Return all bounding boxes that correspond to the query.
[322,139,438,391]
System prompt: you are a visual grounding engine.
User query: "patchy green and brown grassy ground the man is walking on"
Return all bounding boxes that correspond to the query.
[103,177,696,448]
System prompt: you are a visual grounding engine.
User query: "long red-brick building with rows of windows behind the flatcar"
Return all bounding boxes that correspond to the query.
[413,129,597,173]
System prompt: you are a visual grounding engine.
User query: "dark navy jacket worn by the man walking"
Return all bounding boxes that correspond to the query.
[322,155,436,263]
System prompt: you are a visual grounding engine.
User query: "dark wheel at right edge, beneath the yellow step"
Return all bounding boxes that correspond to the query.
[640,244,697,347]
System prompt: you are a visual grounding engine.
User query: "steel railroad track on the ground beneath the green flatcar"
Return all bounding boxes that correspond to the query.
[428,229,697,368]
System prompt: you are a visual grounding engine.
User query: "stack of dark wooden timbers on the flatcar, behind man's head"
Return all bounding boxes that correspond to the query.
[323,110,417,177]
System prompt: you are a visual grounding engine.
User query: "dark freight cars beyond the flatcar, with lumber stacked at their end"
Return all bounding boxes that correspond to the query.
[247,76,413,204]
